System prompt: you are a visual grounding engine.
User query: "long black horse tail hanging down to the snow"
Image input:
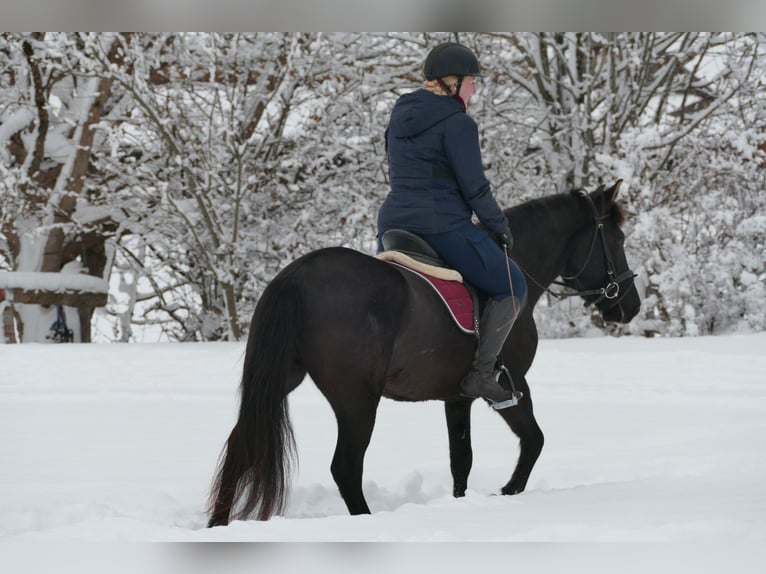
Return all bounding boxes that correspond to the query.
[208,274,305,527]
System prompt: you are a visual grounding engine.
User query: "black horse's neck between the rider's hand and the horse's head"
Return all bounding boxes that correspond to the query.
[508,194,590,308]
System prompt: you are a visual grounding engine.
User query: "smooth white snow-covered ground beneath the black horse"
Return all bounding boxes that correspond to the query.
[0,333,766,572]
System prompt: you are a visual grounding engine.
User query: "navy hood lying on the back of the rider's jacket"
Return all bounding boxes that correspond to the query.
[388,88,465,137]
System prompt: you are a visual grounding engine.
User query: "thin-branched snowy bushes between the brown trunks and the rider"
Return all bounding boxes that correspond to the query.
[85,34,426,340]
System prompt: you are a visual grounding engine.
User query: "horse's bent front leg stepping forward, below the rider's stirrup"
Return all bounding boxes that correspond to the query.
[497,375,544,494]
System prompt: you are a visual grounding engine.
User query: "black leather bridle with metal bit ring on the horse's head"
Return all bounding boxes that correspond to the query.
[522,190,638,311]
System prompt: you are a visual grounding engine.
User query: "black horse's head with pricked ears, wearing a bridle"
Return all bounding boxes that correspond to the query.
[561,180,641,323]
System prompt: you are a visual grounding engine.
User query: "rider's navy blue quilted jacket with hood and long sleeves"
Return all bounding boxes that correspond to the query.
[378,89,508,235]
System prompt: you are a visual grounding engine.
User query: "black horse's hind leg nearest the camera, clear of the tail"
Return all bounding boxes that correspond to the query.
[320,382,380,514]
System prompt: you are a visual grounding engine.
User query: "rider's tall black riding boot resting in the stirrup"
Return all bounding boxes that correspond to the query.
[460,296,521,410]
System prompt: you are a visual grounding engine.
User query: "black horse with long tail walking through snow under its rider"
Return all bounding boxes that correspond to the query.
[208,181,640,526]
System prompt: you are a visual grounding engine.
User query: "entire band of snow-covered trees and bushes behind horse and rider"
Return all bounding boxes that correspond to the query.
[0,32,766,341]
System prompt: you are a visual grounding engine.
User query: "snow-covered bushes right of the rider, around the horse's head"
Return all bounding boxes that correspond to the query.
[464,33,764,334]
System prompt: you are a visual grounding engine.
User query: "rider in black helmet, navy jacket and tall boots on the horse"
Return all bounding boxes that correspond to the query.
[378,42,527,403]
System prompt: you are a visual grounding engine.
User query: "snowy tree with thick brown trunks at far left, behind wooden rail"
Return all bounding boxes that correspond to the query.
[0,33,129,341]
